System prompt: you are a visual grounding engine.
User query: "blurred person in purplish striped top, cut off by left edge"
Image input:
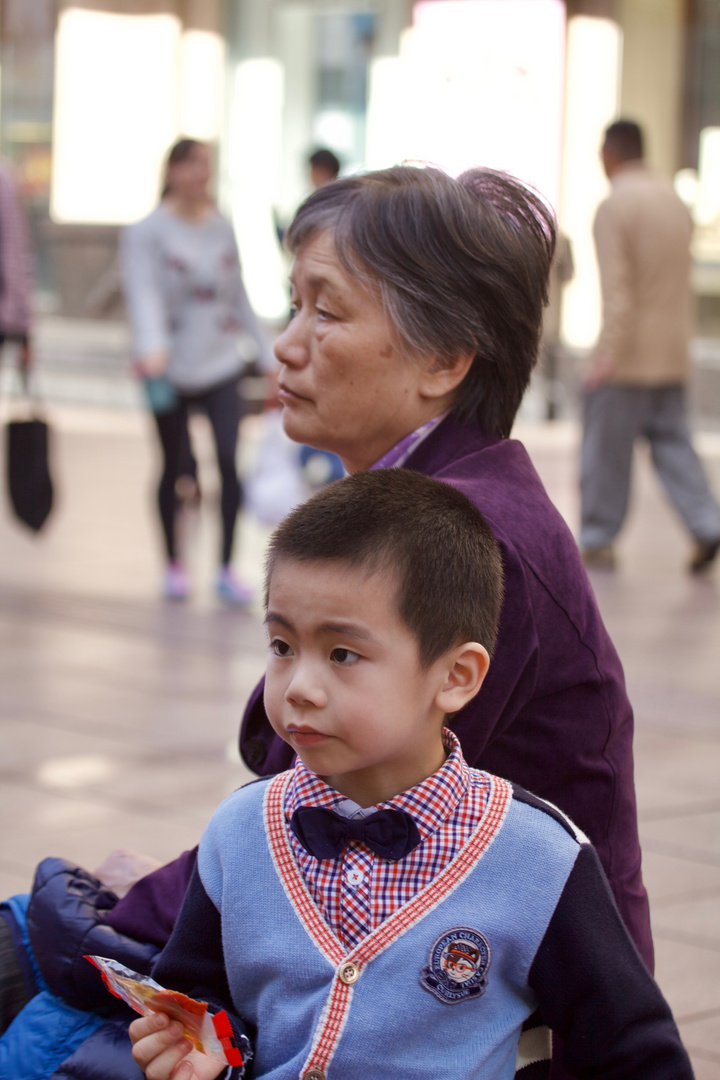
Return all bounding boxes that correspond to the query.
[0,161,32,372]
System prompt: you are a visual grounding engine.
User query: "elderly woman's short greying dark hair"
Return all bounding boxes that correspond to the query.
[285,165,555,437]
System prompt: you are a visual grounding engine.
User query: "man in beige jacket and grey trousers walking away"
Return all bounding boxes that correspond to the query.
[580,120,720,573]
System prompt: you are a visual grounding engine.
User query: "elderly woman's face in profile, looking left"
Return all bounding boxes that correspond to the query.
[275,232,448,472]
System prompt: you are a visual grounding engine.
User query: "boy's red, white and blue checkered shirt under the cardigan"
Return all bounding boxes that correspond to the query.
[285,728,490,949]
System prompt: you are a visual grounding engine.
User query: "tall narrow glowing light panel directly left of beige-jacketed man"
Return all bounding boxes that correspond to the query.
[560,15,622,348]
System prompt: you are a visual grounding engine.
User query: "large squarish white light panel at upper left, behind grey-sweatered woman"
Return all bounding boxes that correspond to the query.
[51,8,180,224]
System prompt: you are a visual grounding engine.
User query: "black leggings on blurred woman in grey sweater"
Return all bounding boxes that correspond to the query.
[155,377,242,566]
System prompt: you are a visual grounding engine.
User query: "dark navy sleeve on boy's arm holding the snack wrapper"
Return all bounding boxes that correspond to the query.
[152,866,253,1080]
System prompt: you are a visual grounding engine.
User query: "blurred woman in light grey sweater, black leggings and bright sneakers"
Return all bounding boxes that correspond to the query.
[121,138,272,604]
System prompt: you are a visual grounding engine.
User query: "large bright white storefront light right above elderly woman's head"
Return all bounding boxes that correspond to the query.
[367,0,565,205]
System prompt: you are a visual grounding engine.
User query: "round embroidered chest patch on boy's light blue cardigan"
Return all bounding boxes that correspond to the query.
[420,927,491,1005]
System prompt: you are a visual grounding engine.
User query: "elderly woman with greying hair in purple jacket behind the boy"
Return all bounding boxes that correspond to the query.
[0,167,652,1078]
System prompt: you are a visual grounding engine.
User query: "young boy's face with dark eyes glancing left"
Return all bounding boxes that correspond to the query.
[264,559,448,807]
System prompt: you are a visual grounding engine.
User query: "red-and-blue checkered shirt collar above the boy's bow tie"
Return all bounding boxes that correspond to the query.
[285,728,470,840]
